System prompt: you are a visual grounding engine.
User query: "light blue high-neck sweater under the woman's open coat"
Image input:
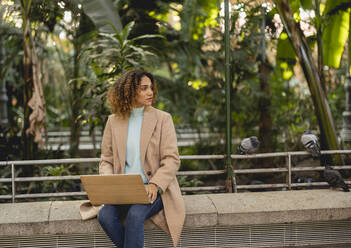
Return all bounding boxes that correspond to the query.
[124,107,148,183]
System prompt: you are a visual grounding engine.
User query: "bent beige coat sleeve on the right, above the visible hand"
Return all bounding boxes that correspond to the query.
[149,114,180,192]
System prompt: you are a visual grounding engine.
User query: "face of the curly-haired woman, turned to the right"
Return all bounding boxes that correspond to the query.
[133,76,154,108]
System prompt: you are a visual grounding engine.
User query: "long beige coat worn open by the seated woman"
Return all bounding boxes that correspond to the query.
[81,107,185,246]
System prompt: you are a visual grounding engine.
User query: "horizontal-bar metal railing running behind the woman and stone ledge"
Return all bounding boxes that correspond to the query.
[0,150,351,202]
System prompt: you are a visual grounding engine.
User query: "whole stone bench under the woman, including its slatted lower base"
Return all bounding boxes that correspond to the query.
[0,190,351,248]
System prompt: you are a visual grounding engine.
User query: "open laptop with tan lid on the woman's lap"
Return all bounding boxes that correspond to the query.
[80,174,150,205]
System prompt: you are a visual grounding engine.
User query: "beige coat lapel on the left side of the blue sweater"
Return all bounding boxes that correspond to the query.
[115,117,128,173]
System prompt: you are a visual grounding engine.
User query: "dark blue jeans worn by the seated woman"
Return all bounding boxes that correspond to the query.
[98,195,163,248]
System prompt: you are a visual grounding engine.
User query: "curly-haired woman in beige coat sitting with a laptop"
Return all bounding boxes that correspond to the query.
[98,69,185,248]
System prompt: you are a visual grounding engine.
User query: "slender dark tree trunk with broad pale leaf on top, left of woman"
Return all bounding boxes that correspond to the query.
[66,0,122,157]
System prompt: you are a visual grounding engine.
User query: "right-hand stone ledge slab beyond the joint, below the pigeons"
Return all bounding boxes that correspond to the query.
[209,190,351,225]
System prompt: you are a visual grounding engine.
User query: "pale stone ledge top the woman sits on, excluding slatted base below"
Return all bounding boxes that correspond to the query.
[0,190,351,236]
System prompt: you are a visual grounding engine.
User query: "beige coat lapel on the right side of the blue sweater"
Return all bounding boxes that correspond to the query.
[140,107,157,165]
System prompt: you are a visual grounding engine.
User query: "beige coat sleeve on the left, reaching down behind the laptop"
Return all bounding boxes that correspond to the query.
[99,116,113,174]
